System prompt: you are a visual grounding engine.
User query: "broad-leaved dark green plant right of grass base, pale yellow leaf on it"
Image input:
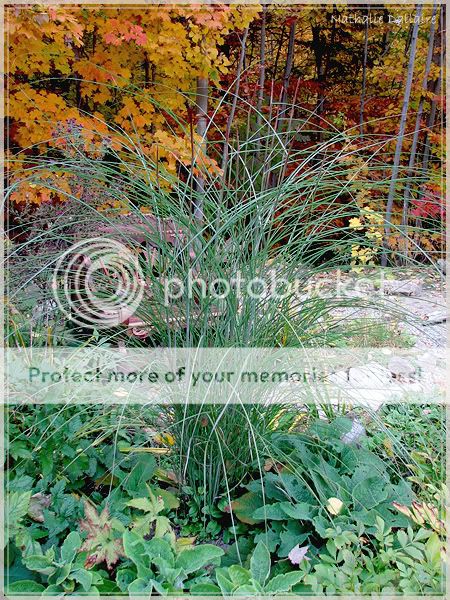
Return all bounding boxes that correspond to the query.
[232,417,413,558]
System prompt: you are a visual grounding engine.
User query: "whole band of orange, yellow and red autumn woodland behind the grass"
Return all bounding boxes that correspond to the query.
[6,5,445,268]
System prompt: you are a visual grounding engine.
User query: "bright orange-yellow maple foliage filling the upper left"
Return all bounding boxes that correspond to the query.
[6,5,259,204]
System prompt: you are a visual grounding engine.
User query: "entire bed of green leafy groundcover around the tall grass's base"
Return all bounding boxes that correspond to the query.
[6,407,445,596]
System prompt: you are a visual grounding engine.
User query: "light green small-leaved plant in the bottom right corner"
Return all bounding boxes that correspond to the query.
[295,517,444,596]
